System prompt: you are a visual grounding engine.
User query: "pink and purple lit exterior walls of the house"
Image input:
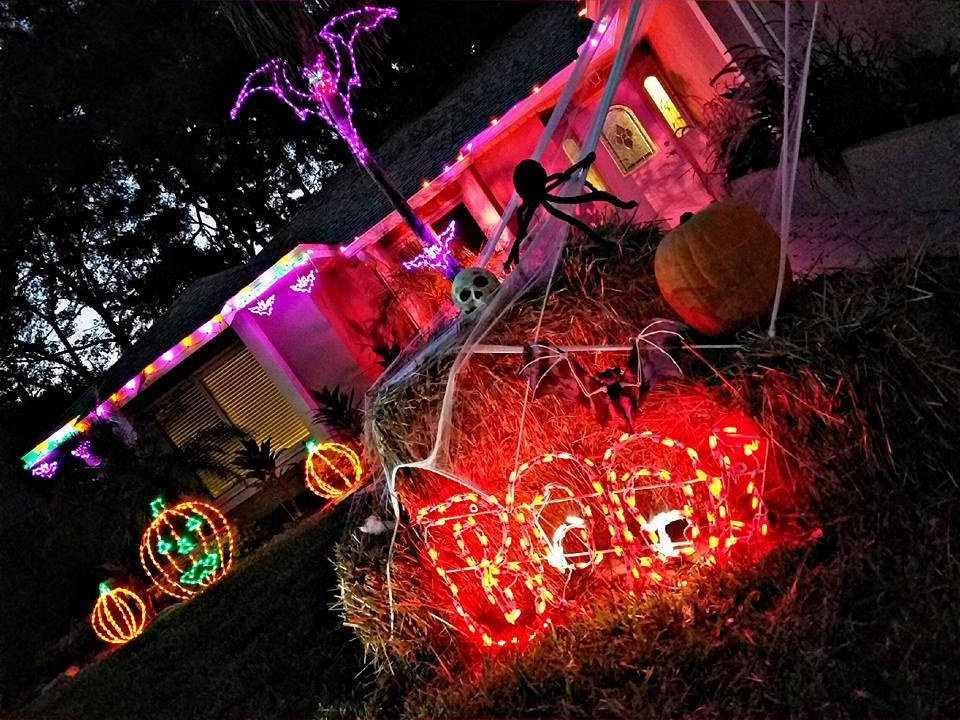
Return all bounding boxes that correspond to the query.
[24,0,744,490]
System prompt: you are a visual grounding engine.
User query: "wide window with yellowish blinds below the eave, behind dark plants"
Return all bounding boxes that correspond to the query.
[155,345,309,497]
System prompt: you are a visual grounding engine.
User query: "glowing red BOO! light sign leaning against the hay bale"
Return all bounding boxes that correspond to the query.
[406,414,770,650]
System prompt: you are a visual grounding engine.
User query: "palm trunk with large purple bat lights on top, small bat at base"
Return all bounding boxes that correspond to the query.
[230,7,460,279]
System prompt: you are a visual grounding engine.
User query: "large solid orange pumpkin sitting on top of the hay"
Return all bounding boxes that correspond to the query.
[654,200,790,335]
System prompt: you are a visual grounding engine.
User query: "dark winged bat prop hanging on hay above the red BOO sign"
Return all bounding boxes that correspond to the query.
[520,320,683,430]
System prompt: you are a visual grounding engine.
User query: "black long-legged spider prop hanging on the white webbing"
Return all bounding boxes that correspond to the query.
[503,153,637,270]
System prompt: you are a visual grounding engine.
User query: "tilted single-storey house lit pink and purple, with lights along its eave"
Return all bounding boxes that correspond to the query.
[23,0,744,510]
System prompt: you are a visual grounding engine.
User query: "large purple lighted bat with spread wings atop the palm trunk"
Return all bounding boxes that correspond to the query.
[230,7,397,165]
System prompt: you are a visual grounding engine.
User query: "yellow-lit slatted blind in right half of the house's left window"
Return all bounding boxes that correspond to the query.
[202,348,309,450]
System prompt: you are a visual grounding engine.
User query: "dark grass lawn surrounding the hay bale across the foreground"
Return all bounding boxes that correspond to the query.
[30,258,960,719]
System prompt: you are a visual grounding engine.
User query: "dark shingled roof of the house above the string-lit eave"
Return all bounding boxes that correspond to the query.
[30,2,589,456]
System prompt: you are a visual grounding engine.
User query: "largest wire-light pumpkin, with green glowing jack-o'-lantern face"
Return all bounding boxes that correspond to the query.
[140,498,233,600]
